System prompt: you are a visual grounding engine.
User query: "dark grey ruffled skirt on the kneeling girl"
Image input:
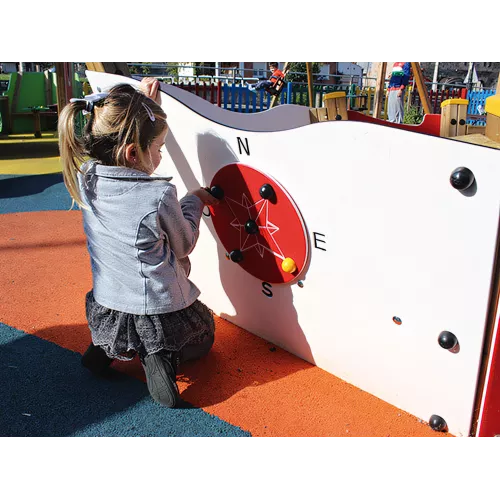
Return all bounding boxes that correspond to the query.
[86,290,215,361]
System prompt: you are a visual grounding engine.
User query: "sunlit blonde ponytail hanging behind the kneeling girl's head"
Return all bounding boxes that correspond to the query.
[57,101,88,209]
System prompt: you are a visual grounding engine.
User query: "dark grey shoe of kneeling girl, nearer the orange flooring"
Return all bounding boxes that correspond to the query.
[141,350,182,408]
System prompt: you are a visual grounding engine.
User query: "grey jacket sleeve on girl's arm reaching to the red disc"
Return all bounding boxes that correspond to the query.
[158,185,204,259]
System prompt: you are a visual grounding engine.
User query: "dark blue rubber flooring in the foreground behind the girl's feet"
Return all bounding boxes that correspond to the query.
[0,323,251,439]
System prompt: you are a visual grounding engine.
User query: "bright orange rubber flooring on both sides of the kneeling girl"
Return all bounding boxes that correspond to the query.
[0,210,452,439]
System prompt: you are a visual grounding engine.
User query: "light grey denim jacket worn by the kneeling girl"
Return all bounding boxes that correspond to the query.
[78,161,203,315]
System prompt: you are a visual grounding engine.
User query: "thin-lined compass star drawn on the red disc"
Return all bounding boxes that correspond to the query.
[225,193,285,260]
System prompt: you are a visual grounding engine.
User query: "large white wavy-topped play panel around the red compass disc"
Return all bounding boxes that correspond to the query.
[88,72,500,436]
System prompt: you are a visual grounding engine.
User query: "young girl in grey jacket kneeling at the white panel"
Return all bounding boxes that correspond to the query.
[58,78,218,408]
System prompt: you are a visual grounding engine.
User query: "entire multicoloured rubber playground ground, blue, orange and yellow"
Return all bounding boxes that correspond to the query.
[0,136,453,439]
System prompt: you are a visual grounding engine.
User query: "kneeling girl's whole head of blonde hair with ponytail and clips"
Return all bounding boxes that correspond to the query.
[57,84,167,208]
